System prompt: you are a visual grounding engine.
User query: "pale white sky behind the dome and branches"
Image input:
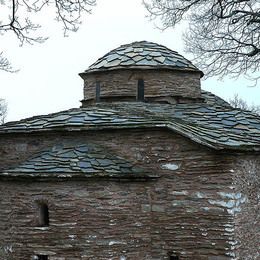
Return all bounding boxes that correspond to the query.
[0,0,260,121]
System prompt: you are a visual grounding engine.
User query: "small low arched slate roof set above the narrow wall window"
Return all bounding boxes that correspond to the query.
[0,143,156,179]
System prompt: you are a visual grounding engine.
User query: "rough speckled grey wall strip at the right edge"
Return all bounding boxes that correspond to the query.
[230,155,260,260]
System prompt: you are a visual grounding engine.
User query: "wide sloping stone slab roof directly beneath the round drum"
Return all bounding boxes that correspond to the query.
[0,92,260,151]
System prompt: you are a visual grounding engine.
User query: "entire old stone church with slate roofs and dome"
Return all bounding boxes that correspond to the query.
[0,41,260,260]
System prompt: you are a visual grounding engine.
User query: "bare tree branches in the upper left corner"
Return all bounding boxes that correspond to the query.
[0,0,96,71]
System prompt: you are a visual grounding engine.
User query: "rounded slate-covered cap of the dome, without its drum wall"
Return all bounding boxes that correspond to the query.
[85,41,203,75]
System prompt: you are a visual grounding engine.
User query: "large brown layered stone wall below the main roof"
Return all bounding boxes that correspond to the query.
[0,130,252,260]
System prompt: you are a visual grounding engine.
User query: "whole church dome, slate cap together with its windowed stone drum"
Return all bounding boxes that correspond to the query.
[79,41,203,106]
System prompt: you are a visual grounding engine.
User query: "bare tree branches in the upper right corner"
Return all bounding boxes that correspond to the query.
[143,0,260,82]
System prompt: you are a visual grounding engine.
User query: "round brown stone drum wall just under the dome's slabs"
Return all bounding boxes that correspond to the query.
[83,70,201,100]
